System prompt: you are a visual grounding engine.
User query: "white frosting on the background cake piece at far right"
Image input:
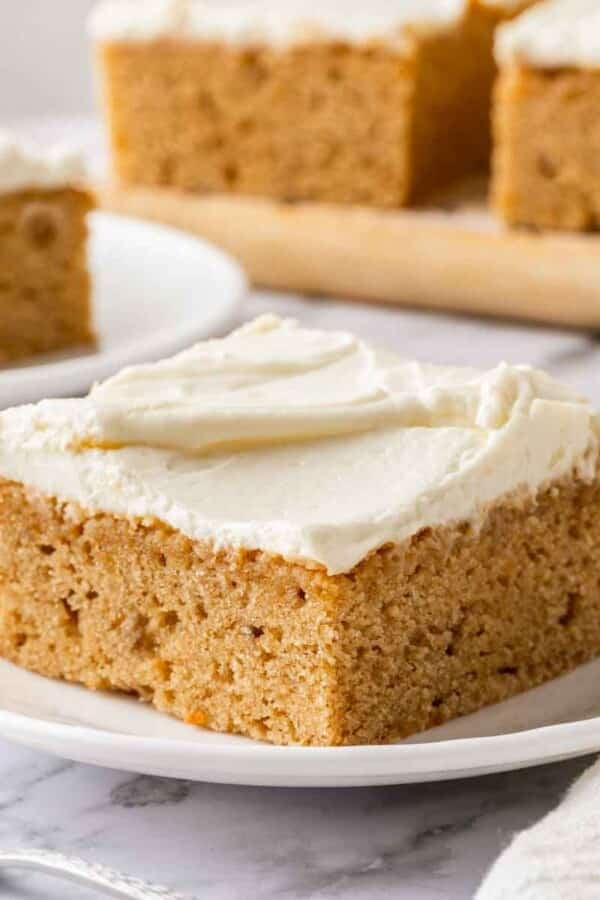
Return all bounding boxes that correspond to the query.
[496,0,600,68]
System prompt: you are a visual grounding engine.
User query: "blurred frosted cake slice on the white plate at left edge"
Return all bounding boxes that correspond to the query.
[0,132,94,363]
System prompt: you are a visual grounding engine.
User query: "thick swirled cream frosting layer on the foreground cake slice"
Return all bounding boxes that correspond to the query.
[0,317,598,574]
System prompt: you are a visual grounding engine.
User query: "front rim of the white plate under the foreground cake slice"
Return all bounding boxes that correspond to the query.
[0,676,600,787]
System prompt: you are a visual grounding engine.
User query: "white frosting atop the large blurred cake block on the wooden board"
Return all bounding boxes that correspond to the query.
[89,0,476,45]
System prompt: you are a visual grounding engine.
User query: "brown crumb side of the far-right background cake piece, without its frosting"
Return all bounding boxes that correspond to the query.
[492,64,600,231]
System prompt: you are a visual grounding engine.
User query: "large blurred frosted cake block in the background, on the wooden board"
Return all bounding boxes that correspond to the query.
[90,0,532,207]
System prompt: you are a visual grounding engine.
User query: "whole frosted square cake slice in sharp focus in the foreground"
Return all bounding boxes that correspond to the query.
[0,317,600,745]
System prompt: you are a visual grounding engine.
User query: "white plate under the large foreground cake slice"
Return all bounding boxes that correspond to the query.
[0,660,600,787]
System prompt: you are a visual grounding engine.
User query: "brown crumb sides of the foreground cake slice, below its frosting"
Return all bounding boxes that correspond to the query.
[0,477,600,745]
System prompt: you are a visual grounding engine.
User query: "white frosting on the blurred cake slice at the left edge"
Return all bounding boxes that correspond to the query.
[0,131,85,194]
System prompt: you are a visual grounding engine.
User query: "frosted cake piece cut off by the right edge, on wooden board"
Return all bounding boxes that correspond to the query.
[493,0,600,231]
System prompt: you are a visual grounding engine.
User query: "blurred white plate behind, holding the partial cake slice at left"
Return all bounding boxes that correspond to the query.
[0,212,246,407]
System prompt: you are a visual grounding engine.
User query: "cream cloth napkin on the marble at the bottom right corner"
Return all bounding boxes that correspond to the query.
[474,760,600,900]
